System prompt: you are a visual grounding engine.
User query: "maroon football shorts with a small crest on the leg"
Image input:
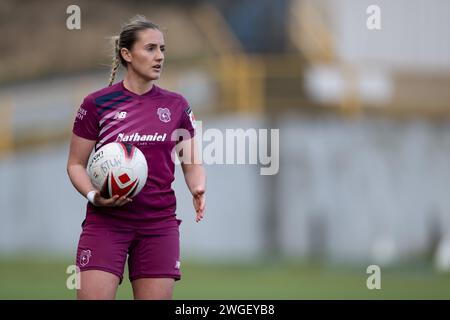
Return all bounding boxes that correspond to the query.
[76,215,181,283]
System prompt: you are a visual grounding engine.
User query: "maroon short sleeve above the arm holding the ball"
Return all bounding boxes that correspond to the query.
[72,96,99,140]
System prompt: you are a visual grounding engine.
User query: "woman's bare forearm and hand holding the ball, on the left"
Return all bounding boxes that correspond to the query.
[67,134,131,206]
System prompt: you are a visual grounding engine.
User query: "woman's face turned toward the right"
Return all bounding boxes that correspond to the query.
[122,29,165,81]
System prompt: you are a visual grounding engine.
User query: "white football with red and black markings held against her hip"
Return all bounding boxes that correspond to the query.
[87,142,148,198]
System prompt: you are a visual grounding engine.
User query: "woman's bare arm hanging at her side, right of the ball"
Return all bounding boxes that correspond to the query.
[177,138,206,222]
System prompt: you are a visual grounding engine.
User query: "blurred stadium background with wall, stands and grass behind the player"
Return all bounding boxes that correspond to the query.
[0,0,450,299]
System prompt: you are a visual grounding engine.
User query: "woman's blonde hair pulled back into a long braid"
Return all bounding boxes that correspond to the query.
[108,15,160,86]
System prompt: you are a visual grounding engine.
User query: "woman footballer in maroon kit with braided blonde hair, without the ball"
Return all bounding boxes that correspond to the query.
[67,16,206,299]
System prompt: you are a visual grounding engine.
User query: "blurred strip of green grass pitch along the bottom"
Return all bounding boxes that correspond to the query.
[0,257,450,300]
